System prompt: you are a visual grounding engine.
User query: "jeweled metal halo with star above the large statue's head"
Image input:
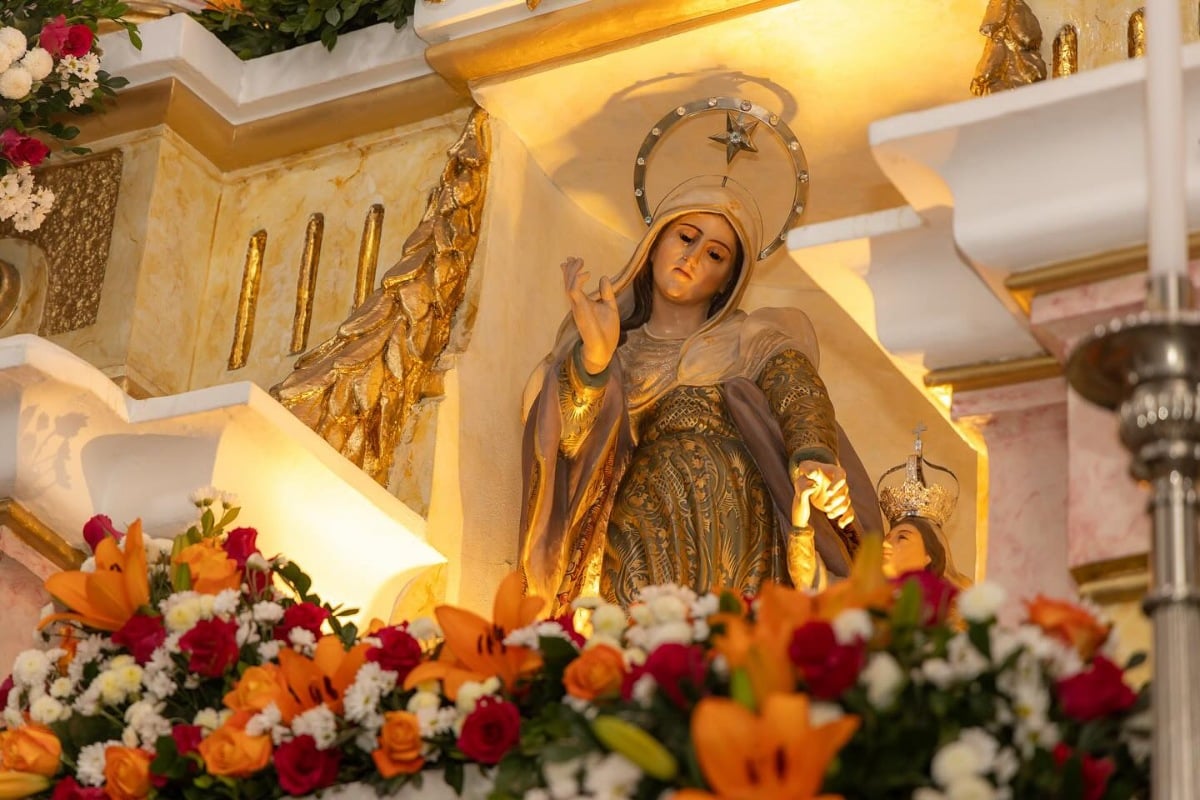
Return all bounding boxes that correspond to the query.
[634,97,809,260]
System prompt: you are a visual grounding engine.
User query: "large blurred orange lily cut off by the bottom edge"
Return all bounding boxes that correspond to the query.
[676,694,858,800]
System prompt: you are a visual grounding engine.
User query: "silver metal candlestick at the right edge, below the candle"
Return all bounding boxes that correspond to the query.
[1067,280,1200,800]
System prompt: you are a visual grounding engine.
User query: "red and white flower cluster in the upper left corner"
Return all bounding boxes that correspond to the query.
[0,0,139,230]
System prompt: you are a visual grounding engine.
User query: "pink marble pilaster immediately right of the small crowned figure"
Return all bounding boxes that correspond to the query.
[953,378,1075,614]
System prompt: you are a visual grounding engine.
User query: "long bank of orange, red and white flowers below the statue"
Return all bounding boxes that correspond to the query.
[0,492,1148,800]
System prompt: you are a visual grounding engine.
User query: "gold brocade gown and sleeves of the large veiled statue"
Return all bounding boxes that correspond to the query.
[558,329,838,604]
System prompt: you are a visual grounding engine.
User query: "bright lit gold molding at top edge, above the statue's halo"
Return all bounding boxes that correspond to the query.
[425,0,788,91]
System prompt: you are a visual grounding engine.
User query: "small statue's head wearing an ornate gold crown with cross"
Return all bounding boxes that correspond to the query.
[876,425,971,588]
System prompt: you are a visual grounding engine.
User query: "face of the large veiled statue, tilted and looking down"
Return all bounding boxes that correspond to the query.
[650,213,738,305]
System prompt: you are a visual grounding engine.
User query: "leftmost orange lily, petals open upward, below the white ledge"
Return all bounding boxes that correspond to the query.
[38,519,150,631]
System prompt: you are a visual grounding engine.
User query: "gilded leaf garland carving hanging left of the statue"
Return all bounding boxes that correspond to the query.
[271,109,491,486]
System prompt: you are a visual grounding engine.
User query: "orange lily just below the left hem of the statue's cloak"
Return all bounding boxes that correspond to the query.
[404,572,546,699]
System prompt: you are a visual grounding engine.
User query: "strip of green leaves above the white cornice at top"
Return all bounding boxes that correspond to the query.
[192,0,415,59]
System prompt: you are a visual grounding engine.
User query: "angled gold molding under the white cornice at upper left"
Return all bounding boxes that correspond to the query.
[74,74,470,172]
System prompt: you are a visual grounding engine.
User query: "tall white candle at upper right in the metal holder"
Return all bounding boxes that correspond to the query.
[1146,0,1188,277]
